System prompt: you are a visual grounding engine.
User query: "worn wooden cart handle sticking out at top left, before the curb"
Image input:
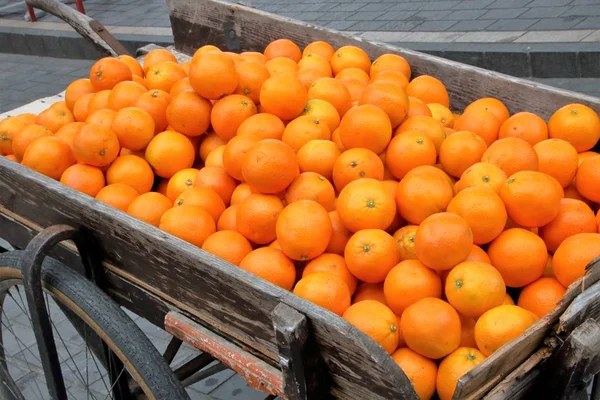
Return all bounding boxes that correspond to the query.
[25,0,129,56]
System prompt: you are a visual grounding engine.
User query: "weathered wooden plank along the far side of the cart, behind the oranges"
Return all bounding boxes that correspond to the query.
[167,0,600,118]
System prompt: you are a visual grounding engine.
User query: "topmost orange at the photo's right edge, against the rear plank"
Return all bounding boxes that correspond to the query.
[548,104,600,153]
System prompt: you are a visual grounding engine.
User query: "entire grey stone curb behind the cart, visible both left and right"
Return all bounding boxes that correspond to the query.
[0,26,600,78]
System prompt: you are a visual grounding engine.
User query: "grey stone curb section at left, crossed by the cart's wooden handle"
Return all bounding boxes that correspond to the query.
[0,27,173,60]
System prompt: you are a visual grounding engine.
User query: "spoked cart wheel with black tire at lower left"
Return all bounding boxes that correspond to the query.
[0,251,189,400]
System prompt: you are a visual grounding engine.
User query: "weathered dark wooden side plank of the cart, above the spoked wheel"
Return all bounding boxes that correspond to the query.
[0,158,415,399]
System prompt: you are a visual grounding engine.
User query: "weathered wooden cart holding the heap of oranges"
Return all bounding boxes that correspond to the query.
[0,0,600,399]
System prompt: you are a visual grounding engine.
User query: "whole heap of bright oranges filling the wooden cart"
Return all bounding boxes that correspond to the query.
[0,39,600,399]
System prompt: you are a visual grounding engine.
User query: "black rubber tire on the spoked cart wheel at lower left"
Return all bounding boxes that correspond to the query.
[0,251,189,400]
